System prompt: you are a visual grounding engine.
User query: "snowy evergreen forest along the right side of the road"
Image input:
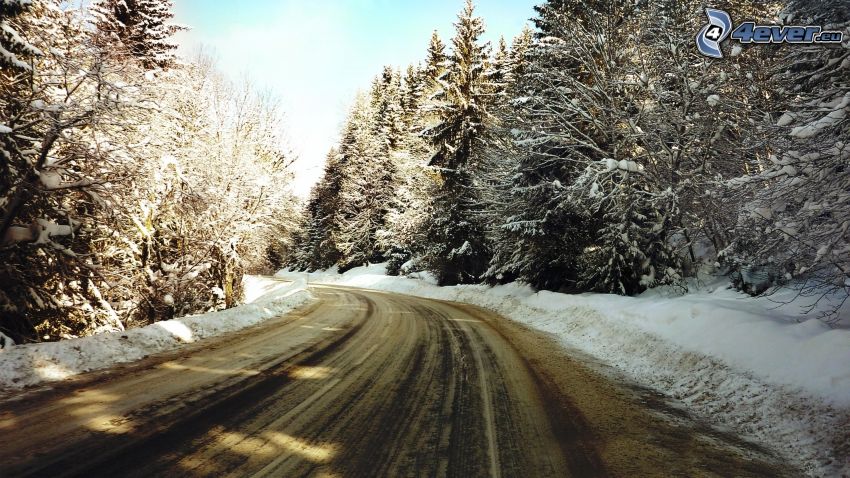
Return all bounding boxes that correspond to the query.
[288,0,850,322]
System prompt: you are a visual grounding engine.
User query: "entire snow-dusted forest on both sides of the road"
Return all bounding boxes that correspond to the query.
[0,0,850,343]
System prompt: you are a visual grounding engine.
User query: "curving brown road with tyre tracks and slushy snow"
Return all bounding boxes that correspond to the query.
[0,286,795,477]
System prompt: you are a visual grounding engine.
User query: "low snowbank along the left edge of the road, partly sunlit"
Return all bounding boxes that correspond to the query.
[0,276,313,390]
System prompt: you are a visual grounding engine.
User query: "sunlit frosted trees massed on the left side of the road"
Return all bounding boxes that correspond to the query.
[0,0,297,342]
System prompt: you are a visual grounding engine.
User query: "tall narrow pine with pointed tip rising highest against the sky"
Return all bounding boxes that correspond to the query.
[419,0,492,284]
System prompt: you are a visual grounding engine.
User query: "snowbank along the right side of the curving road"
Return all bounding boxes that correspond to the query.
[278,265,850,476]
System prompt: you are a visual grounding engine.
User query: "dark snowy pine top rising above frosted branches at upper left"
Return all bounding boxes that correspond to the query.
[91,0,185,69]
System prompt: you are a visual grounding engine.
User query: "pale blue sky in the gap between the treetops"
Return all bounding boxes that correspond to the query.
[174,0,539,194]
